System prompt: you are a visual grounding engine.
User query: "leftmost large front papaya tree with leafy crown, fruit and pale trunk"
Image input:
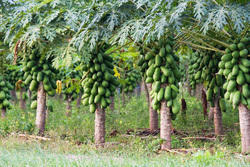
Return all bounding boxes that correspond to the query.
[1,1,77,135]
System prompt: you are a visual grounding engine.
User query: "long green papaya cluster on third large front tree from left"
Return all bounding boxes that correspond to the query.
[138,37,181,114]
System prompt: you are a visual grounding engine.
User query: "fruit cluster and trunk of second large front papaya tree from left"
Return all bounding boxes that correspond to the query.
[82,43,119,146]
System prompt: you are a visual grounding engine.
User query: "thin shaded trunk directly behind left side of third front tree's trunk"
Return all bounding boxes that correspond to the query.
[145,84,159,132]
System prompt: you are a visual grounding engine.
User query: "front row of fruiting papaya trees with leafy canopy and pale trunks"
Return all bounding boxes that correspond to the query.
[0,0,250,152]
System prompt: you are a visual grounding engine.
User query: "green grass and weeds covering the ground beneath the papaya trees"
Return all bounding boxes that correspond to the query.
[0,92,250,167]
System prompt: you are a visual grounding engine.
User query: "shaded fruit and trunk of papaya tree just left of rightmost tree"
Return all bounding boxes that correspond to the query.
[189,51,226,135]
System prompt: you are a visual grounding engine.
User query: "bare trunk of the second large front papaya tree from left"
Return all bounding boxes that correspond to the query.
[95,104,105,146]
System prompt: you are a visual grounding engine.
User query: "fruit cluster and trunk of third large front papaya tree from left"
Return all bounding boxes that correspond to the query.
[139,35,180,149]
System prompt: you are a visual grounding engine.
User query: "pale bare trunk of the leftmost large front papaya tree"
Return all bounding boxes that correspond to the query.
[36,82,46,136]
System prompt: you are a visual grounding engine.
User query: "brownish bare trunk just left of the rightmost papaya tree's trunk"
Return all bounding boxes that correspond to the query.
[213,97,223,136]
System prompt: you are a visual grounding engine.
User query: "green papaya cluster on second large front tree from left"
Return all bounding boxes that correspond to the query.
[82,46,119,112]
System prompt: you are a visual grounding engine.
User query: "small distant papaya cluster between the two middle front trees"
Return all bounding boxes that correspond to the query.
[122,69,141,93]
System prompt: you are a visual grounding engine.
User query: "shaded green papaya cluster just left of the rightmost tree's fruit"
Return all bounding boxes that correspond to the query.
[189,51,226,112]
